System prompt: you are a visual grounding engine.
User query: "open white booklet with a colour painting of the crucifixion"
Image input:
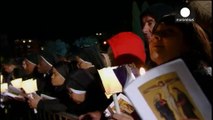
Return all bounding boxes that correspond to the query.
[124,59,212,120]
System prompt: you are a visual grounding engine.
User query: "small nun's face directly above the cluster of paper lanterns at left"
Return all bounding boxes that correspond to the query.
[22,59,36,74]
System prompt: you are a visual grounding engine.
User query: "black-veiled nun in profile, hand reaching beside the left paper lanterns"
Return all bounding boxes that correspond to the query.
[28,61,78,112]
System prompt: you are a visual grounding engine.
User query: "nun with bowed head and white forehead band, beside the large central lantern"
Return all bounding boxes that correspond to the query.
[67,67,111,115]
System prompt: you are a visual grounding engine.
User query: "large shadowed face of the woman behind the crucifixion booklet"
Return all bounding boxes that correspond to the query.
[149,23,187,64]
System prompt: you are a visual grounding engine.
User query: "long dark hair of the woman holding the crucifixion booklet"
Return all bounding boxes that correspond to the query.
[153,13,212,65]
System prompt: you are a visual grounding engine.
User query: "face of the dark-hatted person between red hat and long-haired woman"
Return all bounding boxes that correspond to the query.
[142,16,156,41]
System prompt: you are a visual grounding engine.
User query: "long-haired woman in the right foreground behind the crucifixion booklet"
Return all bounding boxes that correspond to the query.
[149,13,212,103]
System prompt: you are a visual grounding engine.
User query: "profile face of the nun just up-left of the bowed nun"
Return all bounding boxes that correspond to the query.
[51,68,65,86]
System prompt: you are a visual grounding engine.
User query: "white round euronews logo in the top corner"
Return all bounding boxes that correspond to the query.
[176,7,195,22]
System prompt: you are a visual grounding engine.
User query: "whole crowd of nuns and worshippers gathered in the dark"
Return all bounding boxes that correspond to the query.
[1,0,212,120]
